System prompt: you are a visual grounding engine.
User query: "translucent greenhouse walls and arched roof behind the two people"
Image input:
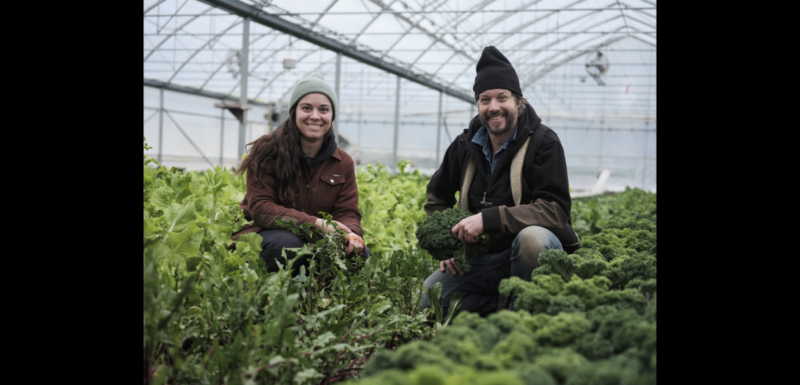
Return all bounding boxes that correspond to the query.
[144,0,656,192]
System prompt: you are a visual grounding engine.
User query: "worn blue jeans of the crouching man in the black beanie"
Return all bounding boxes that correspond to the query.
[420,226,563,317]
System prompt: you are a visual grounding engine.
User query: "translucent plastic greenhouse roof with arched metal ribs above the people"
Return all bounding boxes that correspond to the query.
[144,0,656,106]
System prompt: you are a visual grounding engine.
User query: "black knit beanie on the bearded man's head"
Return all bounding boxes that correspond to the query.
[472,45,522,100]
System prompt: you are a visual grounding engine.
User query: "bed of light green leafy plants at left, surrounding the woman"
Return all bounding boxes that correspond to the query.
[143,139,434,384]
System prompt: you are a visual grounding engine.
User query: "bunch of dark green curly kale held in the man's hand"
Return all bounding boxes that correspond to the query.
[414,209,489,272]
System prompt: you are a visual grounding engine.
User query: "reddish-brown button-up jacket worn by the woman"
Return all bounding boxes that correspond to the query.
[231,147,363,240]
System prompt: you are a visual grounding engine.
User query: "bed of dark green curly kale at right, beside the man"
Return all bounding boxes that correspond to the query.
[348,189,656,385]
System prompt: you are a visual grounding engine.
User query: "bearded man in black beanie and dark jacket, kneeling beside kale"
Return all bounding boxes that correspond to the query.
[421,46,580,316]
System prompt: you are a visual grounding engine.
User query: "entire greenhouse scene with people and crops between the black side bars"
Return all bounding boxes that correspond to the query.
[142,0,658,385]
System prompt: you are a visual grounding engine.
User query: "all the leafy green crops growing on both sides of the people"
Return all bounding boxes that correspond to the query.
[143,138,656,384]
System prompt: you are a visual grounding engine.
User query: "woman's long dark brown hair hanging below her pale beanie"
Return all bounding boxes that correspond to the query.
[236,108,333,204]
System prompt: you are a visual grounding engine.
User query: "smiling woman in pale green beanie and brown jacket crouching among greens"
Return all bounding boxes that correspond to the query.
[231,72,369,271]
